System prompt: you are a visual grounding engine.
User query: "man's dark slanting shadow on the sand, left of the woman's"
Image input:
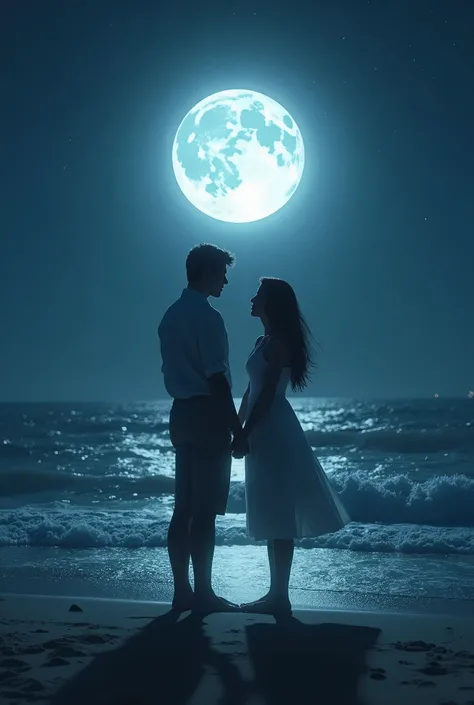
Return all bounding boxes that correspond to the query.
[51,611,244,705]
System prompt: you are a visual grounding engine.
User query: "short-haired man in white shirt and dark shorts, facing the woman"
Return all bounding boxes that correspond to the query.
[158,244,248,613]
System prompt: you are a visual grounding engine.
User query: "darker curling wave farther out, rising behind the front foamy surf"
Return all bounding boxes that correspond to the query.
[0,470,474,527]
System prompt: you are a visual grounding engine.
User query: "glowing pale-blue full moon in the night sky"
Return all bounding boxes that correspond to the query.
[173,89,304,223]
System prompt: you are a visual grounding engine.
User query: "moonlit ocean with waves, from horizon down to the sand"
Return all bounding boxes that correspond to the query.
[0,397,474,602]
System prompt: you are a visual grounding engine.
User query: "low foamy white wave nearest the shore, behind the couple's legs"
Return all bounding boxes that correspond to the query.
[0,507,474,554]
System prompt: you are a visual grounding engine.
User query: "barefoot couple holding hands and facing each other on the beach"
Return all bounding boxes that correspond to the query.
[158,244,350,614]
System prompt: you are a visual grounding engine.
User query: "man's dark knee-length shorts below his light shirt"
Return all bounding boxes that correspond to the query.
[170,396,232,515]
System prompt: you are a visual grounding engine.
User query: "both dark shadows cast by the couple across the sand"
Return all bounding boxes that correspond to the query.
[50,612,380,705]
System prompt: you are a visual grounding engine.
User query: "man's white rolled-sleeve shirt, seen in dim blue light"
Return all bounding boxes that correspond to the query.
[158,287,232,399]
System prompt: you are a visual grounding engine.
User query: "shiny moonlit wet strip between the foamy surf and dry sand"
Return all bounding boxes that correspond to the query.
[0,546,474,614]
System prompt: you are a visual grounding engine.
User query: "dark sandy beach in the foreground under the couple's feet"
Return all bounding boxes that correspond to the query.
[0,595,474,705]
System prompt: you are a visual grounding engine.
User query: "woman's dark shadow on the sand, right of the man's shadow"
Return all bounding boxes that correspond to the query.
[246,617,380,705]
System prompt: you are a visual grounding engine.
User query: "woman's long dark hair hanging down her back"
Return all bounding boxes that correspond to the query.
[260,277,316,392]
